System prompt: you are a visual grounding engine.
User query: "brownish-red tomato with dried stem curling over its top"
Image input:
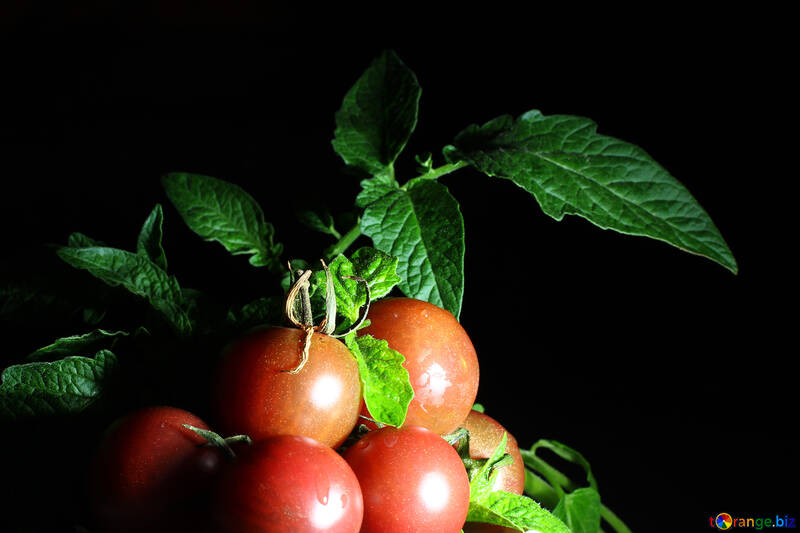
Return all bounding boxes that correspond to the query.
[215,327,361,447]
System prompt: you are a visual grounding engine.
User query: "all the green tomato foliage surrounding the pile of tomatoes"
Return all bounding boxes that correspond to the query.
[0,47,738,533]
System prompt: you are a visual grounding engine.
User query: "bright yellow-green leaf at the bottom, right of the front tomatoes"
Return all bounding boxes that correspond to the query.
[467,433,570,533]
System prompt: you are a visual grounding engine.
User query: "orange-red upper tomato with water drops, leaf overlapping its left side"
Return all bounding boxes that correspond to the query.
[359,298,478,435]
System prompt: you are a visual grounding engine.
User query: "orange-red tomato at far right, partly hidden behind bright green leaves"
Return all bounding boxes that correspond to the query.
[461,411,525,494]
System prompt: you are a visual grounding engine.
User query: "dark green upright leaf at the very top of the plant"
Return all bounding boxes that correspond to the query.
[333,51,422,181]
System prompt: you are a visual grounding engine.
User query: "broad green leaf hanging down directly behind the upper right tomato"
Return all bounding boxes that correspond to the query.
[361,180,464,318]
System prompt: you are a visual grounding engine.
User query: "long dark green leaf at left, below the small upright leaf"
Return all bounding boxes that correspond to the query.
[58,246,192,334]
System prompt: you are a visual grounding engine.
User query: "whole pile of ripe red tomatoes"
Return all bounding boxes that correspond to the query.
[91,298,524,533]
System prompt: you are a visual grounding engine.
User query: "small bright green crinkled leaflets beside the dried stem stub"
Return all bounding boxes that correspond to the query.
[311,247,401,331]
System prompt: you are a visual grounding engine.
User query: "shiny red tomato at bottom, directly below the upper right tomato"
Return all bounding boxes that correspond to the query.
[344,426,469,533]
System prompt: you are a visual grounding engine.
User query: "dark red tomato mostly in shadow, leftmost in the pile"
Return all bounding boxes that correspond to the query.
[90,407,224,532]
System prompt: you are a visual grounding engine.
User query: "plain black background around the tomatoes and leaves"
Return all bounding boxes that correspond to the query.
[0,3,798,531]
